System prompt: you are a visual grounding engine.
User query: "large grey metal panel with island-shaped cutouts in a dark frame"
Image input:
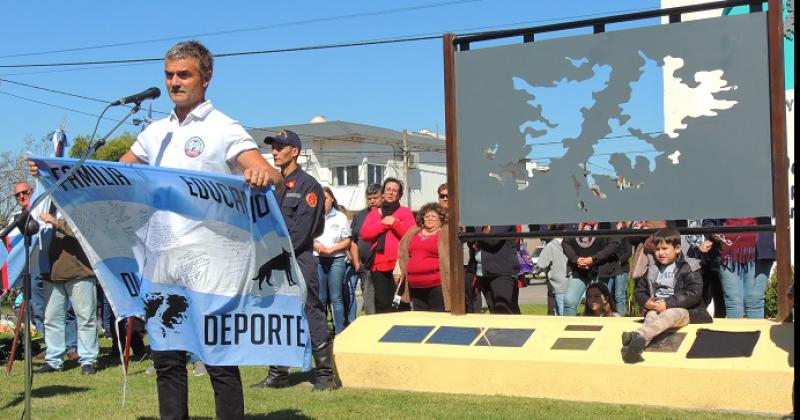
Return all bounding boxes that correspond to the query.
[456,13,773,226]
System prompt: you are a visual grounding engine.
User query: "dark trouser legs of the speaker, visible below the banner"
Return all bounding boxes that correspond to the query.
[153,351,244,420]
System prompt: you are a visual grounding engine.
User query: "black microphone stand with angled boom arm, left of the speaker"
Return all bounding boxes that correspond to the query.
[0,102,142,420]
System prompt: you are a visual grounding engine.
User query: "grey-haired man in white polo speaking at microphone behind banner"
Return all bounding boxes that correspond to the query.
[120,41,281,419]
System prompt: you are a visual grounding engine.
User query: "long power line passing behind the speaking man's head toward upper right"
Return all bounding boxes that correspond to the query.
[0,4,664,68]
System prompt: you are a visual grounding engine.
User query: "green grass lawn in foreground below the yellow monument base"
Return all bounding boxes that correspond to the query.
[0,338,780,420]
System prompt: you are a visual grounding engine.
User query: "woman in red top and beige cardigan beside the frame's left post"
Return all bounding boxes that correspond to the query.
[398,203,450,312]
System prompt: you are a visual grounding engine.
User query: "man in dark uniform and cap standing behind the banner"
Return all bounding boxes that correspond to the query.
[254,130,337,391]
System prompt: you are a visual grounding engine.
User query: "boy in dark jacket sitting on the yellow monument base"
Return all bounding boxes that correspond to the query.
[622,228,712,363]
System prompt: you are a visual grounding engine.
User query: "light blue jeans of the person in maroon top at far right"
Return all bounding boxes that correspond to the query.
[720,260,773,319]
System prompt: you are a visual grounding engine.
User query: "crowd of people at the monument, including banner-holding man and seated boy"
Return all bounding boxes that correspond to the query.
[0,37,792,418]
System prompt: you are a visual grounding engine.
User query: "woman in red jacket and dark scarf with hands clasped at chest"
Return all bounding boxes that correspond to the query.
[361,178,415,313]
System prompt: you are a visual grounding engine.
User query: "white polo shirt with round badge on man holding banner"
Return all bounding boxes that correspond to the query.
[131,101,258,174]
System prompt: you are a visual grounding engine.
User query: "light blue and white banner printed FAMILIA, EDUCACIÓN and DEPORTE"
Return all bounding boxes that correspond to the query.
[30,157,311,369]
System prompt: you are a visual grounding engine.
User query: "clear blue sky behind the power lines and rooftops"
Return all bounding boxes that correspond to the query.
[0,0,659,150]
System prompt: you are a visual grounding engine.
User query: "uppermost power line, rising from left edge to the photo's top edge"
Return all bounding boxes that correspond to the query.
[0,0,483,59]
